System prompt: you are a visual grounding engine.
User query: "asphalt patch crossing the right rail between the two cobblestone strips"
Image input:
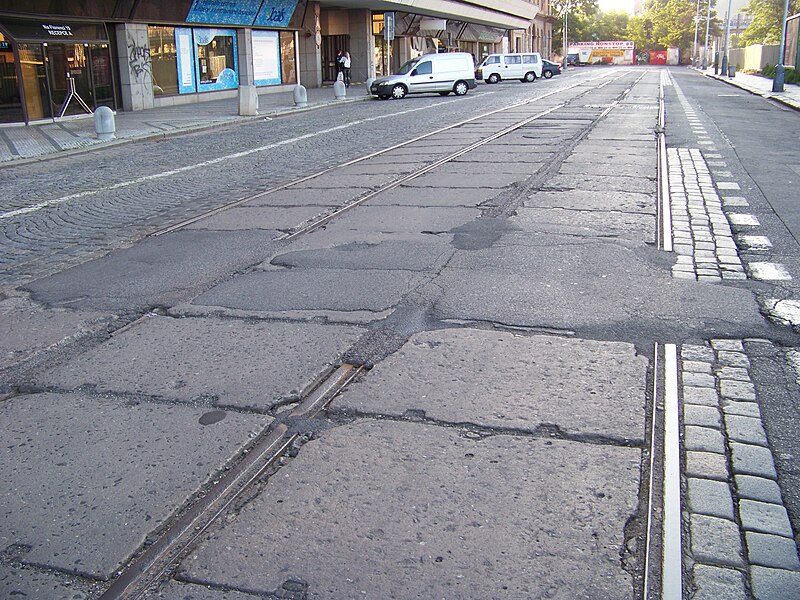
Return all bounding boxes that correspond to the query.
[432,240,769,344]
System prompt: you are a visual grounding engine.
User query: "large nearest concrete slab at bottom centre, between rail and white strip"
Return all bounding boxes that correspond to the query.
[178,420,641,600]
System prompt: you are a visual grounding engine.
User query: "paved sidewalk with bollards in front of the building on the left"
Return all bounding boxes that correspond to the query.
[0,85,370,166]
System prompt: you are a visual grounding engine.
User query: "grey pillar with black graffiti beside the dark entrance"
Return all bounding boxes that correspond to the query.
[115,23,154,111]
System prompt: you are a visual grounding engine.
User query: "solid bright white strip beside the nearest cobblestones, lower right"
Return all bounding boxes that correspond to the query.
[661,344,683,600]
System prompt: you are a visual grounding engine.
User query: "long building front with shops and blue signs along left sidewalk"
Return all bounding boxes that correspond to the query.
[0,0,552,123]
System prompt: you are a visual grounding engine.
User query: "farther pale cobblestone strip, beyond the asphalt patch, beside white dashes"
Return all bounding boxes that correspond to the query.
[667,148,747,282]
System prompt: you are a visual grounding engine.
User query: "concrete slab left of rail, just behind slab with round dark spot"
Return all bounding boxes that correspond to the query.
[39,317,361,410]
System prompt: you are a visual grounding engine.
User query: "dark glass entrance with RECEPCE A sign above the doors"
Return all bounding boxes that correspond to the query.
[0,21,115,123]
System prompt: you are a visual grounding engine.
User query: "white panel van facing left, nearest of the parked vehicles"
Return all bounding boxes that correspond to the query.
[369,52,478,100]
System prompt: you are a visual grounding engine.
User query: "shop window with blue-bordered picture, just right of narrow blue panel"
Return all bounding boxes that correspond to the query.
[194,29,239,92]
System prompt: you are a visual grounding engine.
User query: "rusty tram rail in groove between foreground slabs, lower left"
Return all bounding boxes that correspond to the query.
[95,364,364,600]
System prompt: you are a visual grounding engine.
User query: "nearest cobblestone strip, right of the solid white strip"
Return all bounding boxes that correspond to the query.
[681,340,800,600]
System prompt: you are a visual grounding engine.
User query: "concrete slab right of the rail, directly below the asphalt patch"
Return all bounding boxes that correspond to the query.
[333,329,647,443]
